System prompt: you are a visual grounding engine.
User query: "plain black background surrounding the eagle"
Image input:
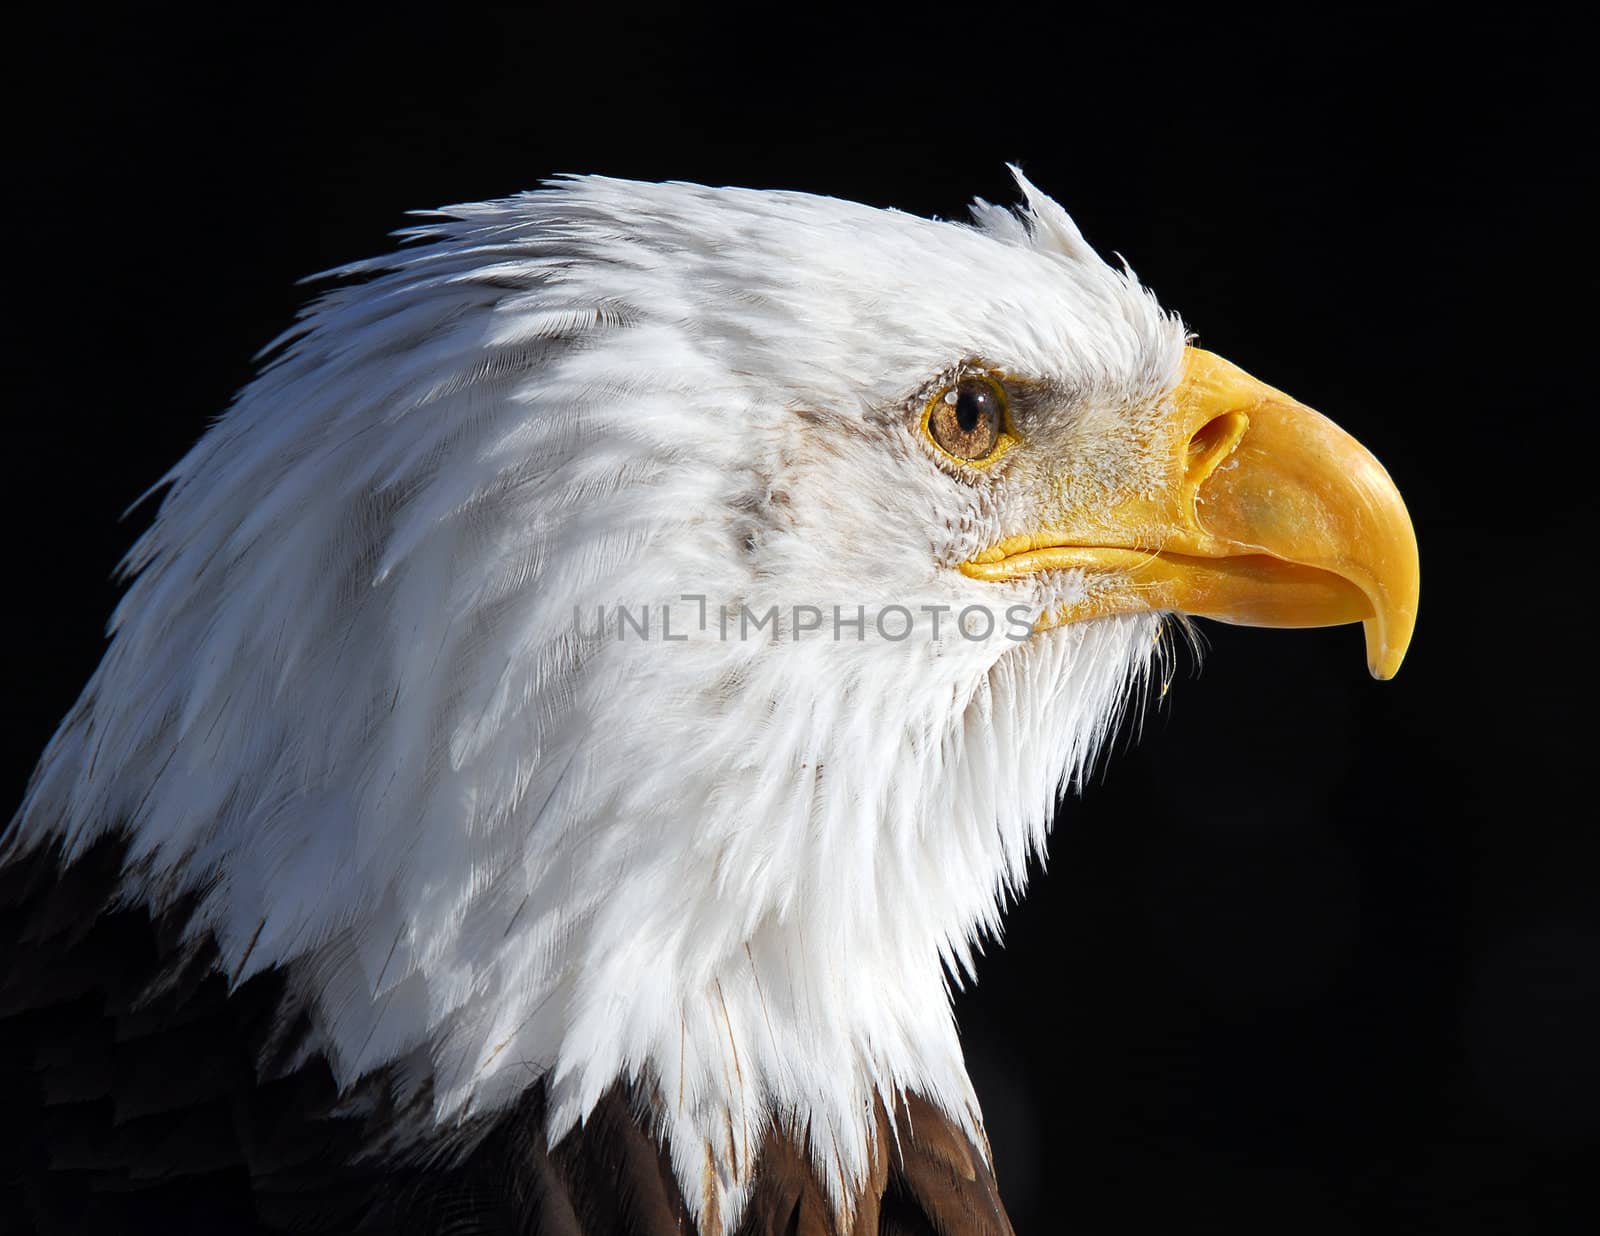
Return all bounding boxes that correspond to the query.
[0,5,1600,1233]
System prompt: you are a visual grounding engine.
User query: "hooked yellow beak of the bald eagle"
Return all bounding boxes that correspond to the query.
[962,347,1419,679]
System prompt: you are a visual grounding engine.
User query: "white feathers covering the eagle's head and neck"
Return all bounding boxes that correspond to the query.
[14,168,1182,1226]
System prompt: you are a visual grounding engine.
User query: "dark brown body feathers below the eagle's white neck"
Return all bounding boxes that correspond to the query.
[0,841,1011,1236]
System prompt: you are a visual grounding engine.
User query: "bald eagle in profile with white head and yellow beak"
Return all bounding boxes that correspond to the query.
[0,173,1418,1236]
